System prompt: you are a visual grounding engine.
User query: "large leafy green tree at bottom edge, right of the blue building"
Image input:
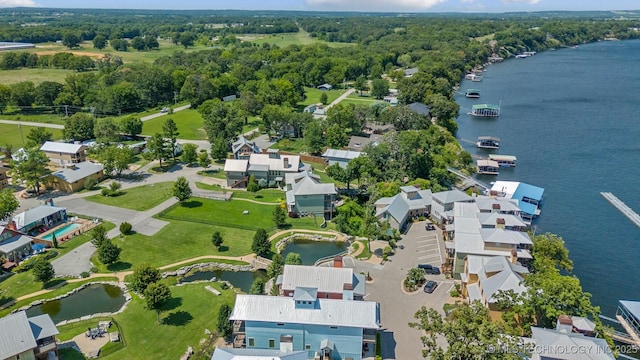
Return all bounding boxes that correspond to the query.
[409,301,526,360]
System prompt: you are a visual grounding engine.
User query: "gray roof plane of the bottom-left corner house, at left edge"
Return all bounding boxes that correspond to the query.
[0,311,37,359]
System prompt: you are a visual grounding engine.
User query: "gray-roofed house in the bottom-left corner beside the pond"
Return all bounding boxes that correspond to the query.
[0,311,60,360]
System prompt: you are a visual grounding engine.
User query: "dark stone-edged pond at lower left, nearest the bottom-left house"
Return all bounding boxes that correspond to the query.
[27,284,125,324]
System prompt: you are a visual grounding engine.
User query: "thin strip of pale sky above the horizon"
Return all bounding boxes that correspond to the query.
[0,0,640,12]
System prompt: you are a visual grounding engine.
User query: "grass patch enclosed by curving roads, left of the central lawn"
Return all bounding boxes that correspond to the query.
[85,182,173,211]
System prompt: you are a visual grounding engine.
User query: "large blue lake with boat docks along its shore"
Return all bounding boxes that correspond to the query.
[456,40,640,316]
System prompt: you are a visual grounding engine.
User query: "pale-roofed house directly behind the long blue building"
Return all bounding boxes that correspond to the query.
[276,262,366,300]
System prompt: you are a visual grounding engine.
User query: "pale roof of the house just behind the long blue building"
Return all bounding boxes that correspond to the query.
[282,265,365,295]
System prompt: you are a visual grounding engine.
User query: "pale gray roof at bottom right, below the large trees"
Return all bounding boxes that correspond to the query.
[531,326,615,360]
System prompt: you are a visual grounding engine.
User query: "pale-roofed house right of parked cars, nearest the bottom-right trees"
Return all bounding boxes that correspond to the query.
[461,255,529,321]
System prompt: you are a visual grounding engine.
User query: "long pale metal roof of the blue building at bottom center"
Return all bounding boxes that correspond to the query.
[229,294,380,329]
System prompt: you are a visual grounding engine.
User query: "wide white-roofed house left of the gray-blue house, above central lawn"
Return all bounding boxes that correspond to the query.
[224,149,305,187]
